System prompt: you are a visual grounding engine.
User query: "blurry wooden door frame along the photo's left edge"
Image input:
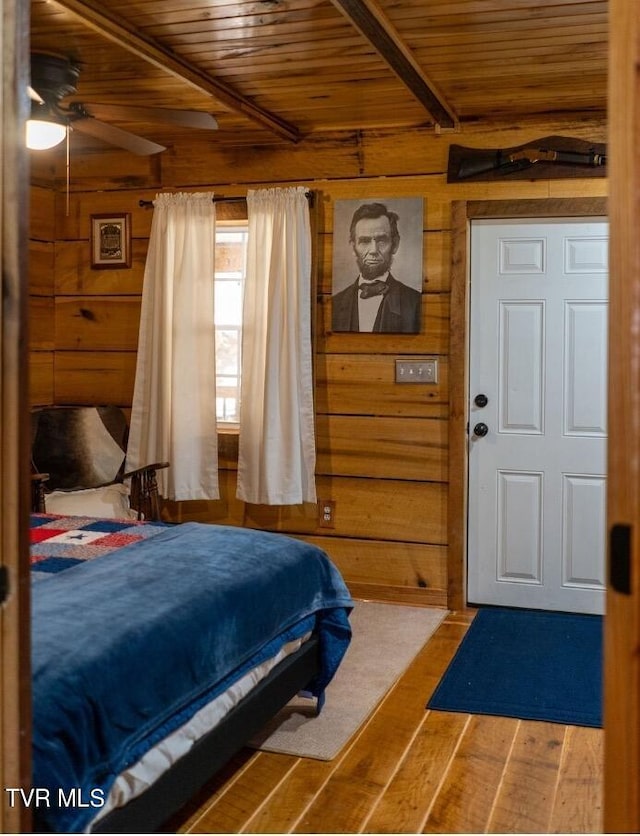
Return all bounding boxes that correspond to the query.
[0,0,31,833]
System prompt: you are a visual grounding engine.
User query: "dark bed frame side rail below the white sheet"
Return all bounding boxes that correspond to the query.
[91,636,319,833]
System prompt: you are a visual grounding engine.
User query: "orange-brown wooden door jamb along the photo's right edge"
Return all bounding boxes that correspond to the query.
[604,0,640,833]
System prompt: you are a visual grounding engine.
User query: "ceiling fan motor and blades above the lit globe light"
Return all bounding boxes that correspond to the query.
[29,52,218,156]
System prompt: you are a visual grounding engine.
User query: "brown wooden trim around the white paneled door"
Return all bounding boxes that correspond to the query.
[447,197,607,609]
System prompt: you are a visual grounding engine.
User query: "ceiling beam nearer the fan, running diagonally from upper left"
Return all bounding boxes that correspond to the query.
[49,0,300,142]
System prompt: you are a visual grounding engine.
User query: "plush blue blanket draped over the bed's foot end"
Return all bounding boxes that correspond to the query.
[32,523,352,832]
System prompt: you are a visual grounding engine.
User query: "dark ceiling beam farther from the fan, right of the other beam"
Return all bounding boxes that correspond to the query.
[331,0,458,129]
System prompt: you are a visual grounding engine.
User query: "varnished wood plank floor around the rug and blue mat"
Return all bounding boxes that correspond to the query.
[170,610,603,833]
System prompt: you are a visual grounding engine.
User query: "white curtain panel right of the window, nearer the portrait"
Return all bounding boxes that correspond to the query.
[237,187,316,505]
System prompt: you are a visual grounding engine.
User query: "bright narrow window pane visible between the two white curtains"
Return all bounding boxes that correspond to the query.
[214,221,247,426]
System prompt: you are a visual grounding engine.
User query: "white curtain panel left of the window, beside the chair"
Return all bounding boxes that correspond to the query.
[126,193,219,500]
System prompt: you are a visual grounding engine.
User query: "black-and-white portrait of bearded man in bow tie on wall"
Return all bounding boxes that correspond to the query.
[331,197,424,334]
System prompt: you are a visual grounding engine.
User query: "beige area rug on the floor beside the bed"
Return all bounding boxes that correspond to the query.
[249,601,447,760]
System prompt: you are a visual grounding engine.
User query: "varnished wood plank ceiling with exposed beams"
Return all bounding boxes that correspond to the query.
[31,0,607,153]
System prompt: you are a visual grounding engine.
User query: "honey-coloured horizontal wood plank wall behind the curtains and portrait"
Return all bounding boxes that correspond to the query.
[31,114,607,606]
